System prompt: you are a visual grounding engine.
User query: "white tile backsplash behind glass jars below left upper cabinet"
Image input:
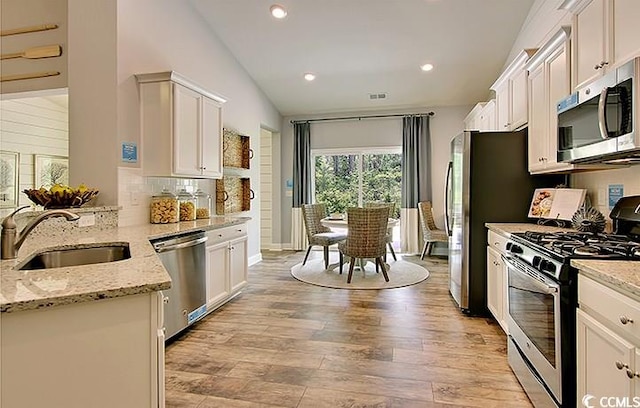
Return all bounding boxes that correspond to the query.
[118,167,215,227]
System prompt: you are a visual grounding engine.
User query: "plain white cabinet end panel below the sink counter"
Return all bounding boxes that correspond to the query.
[0,292,165,408]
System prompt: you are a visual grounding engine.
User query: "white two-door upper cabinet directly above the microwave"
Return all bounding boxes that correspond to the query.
[569,0,640,88]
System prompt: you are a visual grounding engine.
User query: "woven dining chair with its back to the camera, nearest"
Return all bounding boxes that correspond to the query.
[338,207,389,283]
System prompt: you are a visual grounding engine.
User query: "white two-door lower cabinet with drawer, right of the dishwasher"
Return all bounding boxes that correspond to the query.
[206,224,248,311]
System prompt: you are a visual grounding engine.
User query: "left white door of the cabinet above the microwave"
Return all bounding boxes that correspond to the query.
[574,0,609,88]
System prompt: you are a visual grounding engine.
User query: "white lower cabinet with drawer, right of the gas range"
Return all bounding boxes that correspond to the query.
[576,275,640,406]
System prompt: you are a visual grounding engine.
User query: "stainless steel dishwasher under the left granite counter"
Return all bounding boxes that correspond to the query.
[151,232,207,340]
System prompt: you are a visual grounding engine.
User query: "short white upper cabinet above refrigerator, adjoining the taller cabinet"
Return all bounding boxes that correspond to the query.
[491,49,536,131]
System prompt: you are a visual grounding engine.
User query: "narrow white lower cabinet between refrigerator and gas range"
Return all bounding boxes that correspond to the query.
[487,231,509,333]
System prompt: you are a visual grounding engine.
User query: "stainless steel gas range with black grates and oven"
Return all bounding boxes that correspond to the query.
[503,196,640,408]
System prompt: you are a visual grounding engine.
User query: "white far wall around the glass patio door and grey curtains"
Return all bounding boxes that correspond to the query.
[280,106,471,248]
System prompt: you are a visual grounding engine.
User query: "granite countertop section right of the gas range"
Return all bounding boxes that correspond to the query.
[571,259,640,302]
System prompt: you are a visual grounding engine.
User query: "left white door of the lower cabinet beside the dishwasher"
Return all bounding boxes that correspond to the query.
[206,242,230,309]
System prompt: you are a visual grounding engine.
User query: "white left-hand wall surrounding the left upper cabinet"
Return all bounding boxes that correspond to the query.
[69,0,281,257]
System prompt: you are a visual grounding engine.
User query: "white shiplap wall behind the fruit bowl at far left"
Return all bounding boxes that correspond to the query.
[0,97,69,205]
